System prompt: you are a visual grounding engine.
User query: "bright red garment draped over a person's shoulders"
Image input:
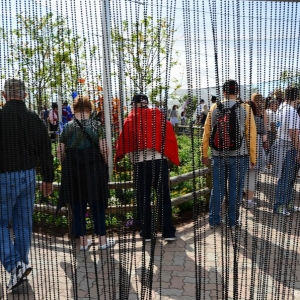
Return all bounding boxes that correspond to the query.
[116,108,179,166]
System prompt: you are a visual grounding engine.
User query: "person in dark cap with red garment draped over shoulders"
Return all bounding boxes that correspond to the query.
[116,94,179,242]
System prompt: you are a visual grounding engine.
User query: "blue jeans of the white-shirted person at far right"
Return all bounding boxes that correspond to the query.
[274,149,299,212]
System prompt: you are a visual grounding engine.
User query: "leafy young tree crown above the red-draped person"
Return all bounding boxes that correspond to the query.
[111,17,181,103]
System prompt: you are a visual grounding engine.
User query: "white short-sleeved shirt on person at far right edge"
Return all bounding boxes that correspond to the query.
[276,103,300,141]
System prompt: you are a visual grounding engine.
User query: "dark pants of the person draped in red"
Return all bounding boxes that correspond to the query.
[134,159,176,239]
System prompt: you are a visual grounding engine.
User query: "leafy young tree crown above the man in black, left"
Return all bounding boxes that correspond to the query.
[0,13,96,109]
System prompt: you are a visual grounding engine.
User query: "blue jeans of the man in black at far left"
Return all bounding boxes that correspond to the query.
[0,169,36,272]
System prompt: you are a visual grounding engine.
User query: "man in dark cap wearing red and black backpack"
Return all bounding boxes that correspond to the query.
[202,79,256,229]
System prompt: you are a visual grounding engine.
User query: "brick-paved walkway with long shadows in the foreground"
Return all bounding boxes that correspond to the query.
[0,176,300,300]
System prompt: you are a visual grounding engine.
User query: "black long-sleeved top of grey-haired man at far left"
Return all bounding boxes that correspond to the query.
[0,100,54,182]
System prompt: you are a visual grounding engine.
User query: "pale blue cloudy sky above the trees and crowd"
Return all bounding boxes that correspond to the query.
[0,0,300,103]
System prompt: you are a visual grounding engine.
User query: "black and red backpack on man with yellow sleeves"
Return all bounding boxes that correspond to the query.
[210,103,243,151]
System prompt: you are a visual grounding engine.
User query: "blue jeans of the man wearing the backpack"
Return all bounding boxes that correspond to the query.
[209,156,249,226]
